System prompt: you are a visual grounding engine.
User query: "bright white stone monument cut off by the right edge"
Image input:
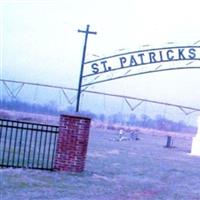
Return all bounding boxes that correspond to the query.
[191,116,200,156]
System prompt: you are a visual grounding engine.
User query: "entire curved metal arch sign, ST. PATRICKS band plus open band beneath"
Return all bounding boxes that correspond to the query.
[82,46,200,86]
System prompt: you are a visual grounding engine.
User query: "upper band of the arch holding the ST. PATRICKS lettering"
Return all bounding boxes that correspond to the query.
[82,46,200,78]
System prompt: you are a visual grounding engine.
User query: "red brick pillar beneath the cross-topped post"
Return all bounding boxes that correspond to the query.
[54,115,90,172]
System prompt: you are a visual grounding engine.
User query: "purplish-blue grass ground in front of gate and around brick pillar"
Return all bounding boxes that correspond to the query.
[0,129,200,200]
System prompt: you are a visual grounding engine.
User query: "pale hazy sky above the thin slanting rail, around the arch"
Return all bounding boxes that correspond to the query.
[0,0,200,111]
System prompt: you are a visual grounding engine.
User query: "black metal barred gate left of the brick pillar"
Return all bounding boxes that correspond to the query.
[0,119,59,170]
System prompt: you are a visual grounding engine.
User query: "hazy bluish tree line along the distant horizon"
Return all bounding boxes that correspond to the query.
[1,99,196,133]
